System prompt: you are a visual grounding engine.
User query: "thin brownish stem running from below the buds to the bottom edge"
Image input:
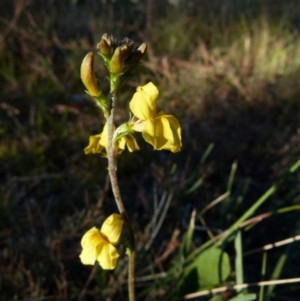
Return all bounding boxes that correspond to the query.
[107,94,135,301]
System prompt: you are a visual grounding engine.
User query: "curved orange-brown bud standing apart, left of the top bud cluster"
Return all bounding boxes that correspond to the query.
[80,52,100,96]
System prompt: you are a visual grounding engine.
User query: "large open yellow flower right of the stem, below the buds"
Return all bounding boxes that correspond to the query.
[129,82,182,153]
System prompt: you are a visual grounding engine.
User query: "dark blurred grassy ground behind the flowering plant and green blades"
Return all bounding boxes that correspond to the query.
[0,0,300,301]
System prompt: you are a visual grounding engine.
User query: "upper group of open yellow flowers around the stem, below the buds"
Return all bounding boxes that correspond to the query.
[84,82,182,154]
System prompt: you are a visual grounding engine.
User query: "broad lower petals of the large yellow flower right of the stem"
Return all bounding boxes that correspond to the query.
[143,112,182,153]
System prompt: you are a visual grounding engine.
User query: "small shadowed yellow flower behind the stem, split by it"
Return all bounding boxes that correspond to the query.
[84,123,140,155]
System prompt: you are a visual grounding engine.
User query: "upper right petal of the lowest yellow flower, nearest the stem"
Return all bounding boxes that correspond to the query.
[100,213,124,244]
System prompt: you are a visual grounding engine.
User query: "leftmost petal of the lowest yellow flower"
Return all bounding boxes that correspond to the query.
[79,227,107,265]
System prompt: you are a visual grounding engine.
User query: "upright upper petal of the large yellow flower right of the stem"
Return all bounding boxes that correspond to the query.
[129,82,158,120]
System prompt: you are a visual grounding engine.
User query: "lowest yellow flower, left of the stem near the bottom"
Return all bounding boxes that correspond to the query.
[79,213,124,270]
